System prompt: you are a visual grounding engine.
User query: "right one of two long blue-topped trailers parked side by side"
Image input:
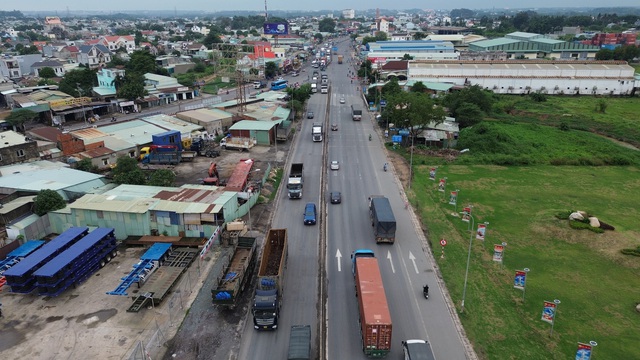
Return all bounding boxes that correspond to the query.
[33,228,118,296]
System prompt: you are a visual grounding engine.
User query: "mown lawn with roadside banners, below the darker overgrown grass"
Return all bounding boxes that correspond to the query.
[412,165,640,360]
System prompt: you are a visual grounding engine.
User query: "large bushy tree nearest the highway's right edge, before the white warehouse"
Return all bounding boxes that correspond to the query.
[382,92,445,137]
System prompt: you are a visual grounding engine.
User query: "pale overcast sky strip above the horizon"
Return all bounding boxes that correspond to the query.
[12,0,640,15]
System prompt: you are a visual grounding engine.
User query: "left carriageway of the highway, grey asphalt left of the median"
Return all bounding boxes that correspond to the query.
[238,60,328,360]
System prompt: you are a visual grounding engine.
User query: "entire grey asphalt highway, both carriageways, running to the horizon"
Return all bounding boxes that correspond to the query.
[238,41,467,360]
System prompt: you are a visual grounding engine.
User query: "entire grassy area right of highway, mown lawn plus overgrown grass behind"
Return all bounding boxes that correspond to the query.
[396,96,640,360]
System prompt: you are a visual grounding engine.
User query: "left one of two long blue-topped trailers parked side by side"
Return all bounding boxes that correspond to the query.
[4,227,89,294]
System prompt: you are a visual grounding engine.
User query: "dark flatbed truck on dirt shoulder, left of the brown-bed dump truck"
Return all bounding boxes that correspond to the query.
[211,237,256,308]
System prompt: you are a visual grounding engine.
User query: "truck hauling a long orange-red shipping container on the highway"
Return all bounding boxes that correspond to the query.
[351,249,392,357]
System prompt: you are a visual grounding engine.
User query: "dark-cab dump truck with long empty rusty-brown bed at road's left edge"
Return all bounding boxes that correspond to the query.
[251,229,288,330]
